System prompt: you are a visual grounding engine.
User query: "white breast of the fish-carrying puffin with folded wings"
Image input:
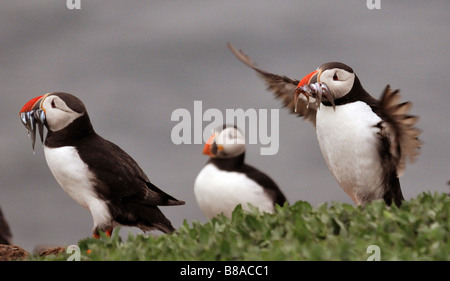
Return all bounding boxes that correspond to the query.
[44,146,109,224]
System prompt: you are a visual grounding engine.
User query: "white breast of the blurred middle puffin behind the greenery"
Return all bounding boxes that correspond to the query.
[194,164,274,218]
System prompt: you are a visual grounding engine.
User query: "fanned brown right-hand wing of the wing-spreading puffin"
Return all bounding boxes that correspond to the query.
[379,85,422,177]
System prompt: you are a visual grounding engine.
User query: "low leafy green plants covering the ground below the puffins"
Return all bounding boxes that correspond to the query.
[29,193,450,261]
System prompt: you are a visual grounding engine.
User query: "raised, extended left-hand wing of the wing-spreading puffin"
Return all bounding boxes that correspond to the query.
[228,43,317,126]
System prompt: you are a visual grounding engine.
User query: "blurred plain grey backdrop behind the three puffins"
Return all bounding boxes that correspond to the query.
[0,0,450,251]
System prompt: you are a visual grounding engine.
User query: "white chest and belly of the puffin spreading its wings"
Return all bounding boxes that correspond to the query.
[316,102,382,204]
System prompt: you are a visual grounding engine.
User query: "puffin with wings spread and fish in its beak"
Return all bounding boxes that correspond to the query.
[228,43,422,206]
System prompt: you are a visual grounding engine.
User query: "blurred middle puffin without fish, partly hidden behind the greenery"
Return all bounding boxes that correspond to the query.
[194,124,287,219]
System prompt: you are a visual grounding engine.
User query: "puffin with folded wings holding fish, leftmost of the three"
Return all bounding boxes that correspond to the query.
[20,92,185,238]
